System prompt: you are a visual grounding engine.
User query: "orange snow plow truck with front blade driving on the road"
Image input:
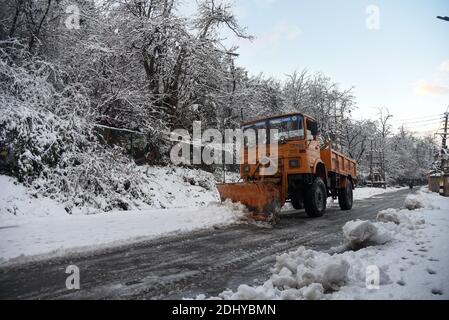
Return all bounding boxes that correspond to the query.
[217,113,357,224]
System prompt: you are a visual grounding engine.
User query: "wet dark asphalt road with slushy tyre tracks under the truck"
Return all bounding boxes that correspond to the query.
[0,189,410,299]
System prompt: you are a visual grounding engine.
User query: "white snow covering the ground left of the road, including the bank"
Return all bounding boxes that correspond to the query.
[0,176,247,264]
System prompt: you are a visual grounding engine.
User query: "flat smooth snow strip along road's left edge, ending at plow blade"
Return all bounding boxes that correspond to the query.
[0,203,248,265]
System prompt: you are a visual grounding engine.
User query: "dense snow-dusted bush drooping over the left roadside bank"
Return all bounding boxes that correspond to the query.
[0,98,157,212]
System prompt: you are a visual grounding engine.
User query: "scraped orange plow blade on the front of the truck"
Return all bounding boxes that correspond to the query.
[217,182,281,224]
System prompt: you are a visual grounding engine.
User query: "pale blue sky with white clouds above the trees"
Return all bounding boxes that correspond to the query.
[179,0,449,132]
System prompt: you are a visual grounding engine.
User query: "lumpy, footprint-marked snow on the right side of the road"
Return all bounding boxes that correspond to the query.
[197,189,449,299]
